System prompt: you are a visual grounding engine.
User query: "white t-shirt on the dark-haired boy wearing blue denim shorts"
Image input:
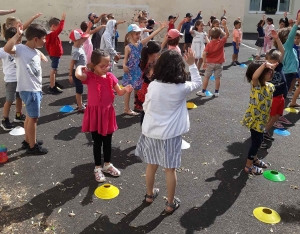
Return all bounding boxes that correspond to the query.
[15,44,42,92]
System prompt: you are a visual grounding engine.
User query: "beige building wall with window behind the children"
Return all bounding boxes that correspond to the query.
[0,0,300,41]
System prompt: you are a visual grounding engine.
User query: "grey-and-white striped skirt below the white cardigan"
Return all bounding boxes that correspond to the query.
[135,134,182,168]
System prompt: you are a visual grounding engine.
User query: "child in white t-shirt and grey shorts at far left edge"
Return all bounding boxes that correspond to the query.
[0,28,26,131]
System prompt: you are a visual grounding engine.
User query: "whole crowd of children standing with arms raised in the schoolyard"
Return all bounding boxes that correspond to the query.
[0,7,300,214]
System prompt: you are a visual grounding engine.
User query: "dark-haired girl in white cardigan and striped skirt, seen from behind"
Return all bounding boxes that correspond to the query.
[135,48,202,214]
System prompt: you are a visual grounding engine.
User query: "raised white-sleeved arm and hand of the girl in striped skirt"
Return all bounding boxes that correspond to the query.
[184,48,202,95]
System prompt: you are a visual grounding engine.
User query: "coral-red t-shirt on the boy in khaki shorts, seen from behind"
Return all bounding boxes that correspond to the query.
[204,37,227,64]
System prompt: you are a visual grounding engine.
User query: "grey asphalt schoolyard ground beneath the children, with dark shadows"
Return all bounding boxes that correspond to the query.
[0,40,300,234]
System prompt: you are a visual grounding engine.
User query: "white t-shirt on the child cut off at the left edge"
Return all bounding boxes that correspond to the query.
[0,48,17,82]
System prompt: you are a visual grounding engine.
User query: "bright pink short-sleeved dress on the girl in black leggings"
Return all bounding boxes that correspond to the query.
[82,71,118,136]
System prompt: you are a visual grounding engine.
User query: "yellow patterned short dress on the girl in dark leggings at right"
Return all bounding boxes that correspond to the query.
[241,82,275,132]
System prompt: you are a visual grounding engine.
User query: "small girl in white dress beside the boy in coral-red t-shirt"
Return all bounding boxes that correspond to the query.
[190,20,209,70]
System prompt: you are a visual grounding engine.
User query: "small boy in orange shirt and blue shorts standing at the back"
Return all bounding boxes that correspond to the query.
[231,20,243,66]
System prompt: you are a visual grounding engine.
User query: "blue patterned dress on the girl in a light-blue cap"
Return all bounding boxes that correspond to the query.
[122,43,143,90]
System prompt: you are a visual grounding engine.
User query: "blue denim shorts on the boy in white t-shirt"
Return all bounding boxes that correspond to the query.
[19,91,43,118]
